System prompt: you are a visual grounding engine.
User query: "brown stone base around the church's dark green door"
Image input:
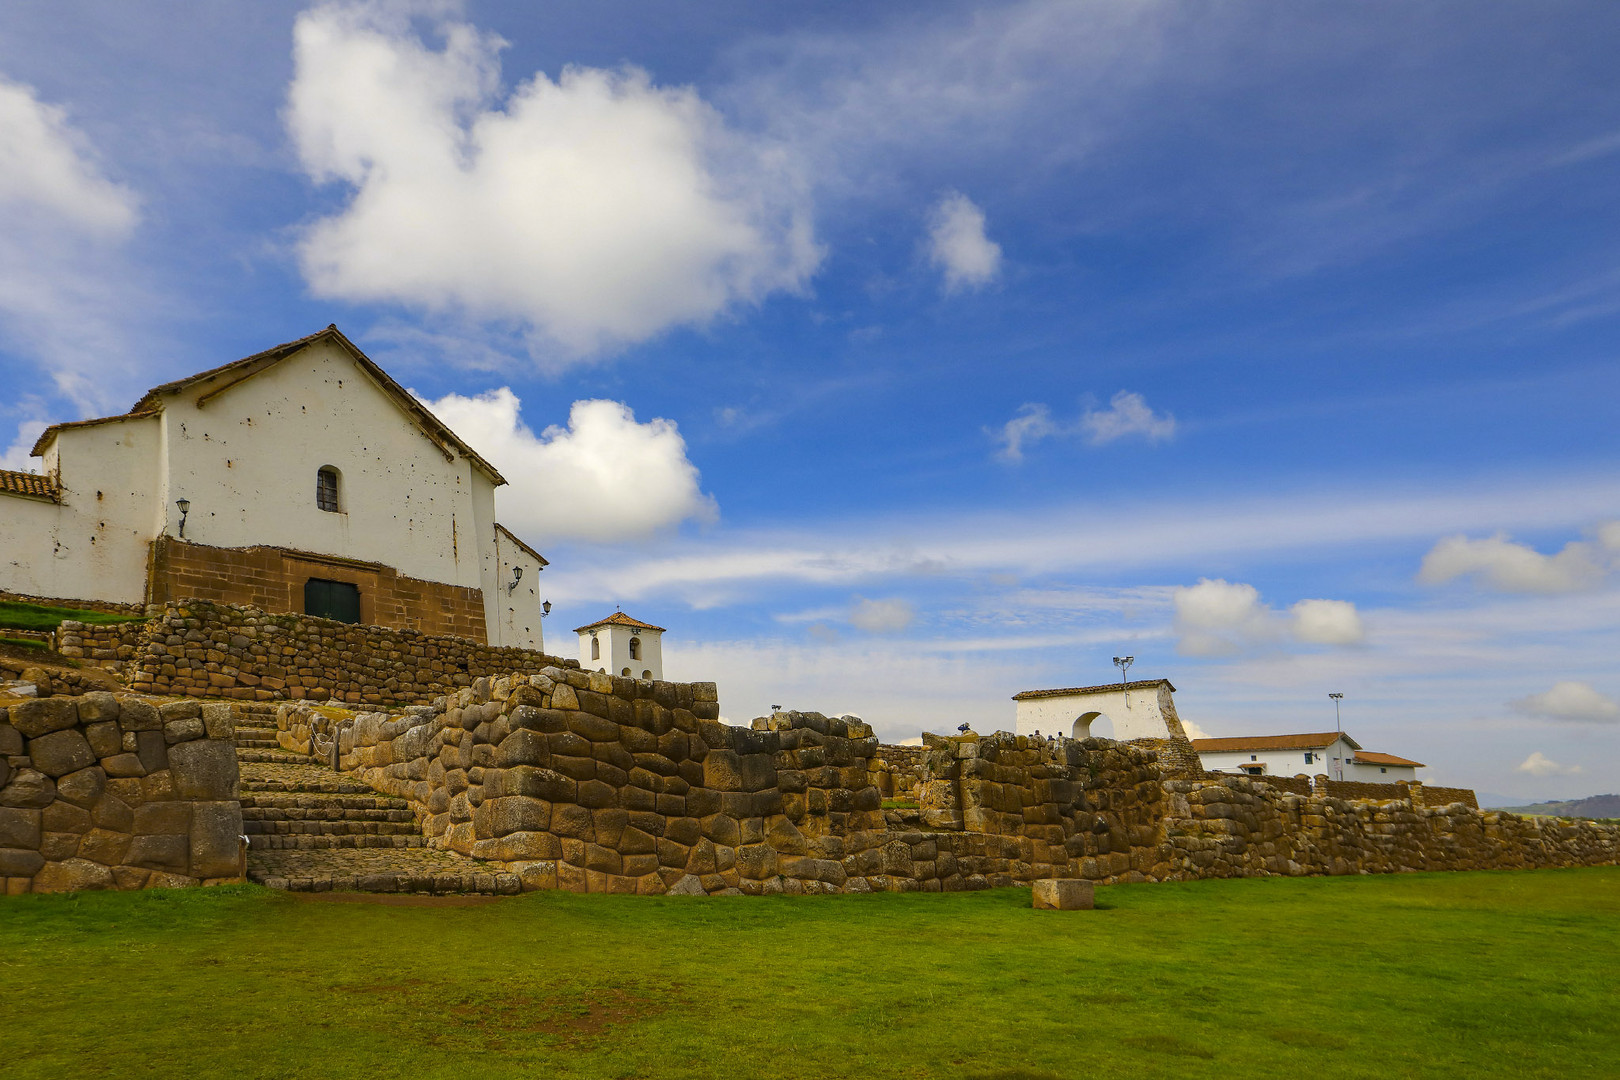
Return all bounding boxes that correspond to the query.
[146,536,489,641]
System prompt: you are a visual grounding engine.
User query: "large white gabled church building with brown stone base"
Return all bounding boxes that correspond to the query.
[0,325,546,649]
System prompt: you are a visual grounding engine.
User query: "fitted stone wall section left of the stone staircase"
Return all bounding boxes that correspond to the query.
[0,691,243,895]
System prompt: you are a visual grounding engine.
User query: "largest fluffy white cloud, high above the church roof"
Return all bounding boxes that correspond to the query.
[287,3,821,356]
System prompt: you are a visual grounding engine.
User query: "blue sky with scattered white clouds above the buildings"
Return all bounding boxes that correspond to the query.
[0,0,1620,797]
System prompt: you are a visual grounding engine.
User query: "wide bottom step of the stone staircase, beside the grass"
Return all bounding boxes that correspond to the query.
[248,848,522,895]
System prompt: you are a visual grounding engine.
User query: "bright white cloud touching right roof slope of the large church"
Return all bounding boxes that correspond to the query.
[426,387,718,542]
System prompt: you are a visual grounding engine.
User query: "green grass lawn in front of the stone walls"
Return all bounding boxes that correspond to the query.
[0,868,1620,1080]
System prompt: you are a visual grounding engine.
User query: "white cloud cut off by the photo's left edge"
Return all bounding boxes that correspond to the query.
[0,76,138,238]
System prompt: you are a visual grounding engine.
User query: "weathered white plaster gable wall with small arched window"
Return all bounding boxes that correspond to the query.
[160,342,496,589]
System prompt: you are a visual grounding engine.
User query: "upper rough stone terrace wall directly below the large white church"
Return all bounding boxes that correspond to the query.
[128,601,578,706]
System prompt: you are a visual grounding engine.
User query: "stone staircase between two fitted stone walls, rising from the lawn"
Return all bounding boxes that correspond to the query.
[235,703,522,894]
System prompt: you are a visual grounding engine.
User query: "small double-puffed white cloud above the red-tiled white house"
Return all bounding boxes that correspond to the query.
[1171,578,1367,656]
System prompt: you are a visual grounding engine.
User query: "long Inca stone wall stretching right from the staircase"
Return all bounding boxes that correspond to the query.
[277,667,1620,894]
